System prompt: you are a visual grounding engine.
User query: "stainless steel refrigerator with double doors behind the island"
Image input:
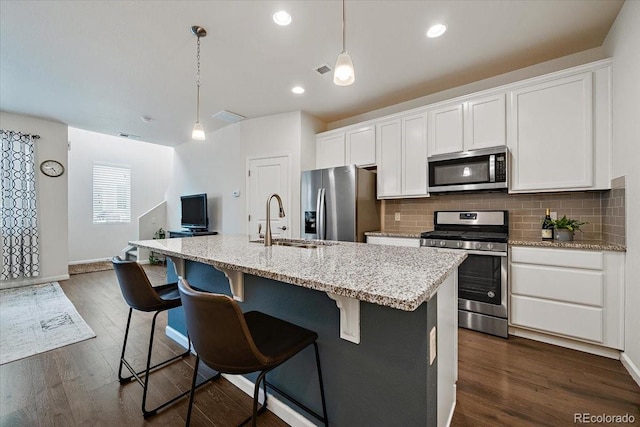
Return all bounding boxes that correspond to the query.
[300,165,380,242]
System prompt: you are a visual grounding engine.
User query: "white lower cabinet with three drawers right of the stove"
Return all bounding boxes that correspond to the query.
[510,246,624,349]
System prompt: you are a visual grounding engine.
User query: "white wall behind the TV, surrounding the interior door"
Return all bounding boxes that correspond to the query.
[167,111,325,236]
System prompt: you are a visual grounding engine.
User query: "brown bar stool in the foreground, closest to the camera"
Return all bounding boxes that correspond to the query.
[178,278,329,427]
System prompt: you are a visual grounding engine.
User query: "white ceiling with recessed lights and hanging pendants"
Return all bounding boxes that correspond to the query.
[0,0,623,146]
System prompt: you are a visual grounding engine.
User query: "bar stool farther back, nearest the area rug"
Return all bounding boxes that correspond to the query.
[111,257,220,419]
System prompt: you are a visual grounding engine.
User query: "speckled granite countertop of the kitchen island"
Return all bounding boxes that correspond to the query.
[129,235,467,311]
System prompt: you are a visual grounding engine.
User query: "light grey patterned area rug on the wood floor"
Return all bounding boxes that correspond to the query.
[0,282,96,365]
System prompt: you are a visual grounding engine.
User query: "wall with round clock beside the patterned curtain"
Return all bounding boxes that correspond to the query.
[0,111,69,288]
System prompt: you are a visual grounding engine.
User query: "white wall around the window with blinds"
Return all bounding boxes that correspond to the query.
[68,128,173,263]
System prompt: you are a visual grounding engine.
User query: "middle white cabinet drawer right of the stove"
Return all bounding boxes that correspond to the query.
[511,264,604,307]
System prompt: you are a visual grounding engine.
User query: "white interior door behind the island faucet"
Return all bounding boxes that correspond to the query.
[247,156,290,237]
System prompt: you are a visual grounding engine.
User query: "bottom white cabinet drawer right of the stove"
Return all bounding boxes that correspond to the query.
[511,295,603,343]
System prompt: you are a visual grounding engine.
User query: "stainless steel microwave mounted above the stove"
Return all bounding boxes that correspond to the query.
[428,146,509,193]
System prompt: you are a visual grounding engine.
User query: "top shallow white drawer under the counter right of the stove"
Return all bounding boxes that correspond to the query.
[511,246,604,270]
